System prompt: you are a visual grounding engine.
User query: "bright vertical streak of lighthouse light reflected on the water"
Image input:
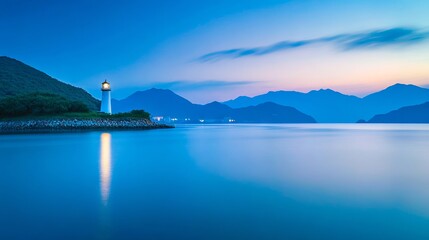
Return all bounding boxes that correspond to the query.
[100,133,112,205]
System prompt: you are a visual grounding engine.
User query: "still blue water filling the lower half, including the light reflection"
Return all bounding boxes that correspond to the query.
[0,124,429,240]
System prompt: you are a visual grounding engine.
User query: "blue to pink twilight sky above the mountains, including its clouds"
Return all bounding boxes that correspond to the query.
[0,0,429,103]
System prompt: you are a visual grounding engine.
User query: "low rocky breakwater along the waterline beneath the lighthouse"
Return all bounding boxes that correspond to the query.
[0,119,173,133]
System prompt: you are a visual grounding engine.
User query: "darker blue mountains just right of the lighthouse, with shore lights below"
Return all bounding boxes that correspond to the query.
[112,88,315,123]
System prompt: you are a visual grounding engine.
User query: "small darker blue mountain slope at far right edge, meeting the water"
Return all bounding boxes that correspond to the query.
[368,102,429,123]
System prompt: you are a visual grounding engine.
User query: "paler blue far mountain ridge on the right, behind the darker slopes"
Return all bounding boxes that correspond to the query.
[224,84,429,123]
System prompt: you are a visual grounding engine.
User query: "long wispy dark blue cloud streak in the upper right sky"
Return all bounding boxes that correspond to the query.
[197,27,429,62]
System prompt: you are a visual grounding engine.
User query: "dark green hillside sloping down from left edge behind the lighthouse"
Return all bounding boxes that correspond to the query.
[0,57,100,111]
